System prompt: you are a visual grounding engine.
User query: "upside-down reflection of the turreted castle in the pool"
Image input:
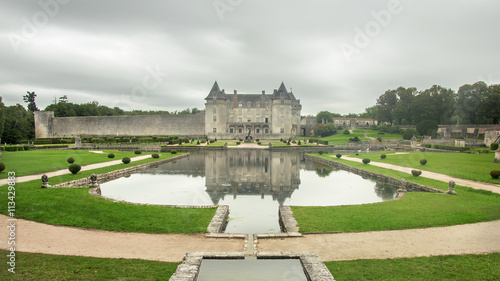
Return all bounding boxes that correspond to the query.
[205,150,301,205]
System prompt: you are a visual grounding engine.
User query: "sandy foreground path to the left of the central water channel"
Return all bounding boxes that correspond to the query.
[0,215,244,262]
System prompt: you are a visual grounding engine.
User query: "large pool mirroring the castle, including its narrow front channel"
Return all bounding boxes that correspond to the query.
[101,149,397,233]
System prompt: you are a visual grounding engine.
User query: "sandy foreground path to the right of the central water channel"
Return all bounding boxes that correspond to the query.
[257,220,500,261]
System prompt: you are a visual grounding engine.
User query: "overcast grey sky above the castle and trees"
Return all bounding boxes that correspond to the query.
[0,0,500,115]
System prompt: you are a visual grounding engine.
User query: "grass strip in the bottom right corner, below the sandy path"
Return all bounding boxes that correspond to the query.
[325,253,500,281]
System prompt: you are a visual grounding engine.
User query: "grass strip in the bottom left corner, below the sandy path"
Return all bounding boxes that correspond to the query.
[0,250,179,281]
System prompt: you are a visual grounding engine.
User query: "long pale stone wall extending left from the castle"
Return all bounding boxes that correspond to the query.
[35,111,205,138]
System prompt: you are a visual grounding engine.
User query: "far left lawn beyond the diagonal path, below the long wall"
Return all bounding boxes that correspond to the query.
[0,150,138,179]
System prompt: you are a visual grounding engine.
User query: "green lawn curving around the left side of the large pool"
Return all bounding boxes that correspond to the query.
[0,153,216,233]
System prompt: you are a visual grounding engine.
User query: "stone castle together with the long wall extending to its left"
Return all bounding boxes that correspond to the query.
[35,82,305,139]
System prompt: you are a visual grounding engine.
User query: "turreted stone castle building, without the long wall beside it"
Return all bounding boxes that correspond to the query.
[205,81,302,139]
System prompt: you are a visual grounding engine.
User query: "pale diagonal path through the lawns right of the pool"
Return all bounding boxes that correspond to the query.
[342,156,500,193]
